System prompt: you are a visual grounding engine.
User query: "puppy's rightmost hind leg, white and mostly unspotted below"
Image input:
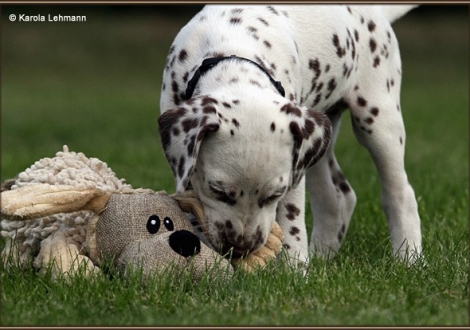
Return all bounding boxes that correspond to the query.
[351,91,421,263]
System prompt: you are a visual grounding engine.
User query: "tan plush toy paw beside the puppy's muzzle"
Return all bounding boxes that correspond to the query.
[232,222,284,272]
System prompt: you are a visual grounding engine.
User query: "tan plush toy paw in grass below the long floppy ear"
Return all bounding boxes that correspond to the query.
[34,233,99,280]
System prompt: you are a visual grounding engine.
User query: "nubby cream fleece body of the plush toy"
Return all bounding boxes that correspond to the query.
[1,146,132,266]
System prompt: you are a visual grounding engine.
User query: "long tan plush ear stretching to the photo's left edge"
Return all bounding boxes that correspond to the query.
[1,184,111,220]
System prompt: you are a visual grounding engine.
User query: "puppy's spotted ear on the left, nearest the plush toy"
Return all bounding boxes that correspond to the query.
[158,96,220,193]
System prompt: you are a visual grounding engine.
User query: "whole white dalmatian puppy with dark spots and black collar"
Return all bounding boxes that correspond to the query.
[159,5,421,263]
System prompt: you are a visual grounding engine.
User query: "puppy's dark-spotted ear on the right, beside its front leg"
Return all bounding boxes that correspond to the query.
[281,103,332,188]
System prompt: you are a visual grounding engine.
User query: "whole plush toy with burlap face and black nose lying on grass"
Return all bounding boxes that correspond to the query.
[1,146,283,281]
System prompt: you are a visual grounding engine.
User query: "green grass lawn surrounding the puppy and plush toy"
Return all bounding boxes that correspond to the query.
[1,6,469,326]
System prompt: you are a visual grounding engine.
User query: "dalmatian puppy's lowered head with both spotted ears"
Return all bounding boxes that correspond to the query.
[159,96,331,257]
